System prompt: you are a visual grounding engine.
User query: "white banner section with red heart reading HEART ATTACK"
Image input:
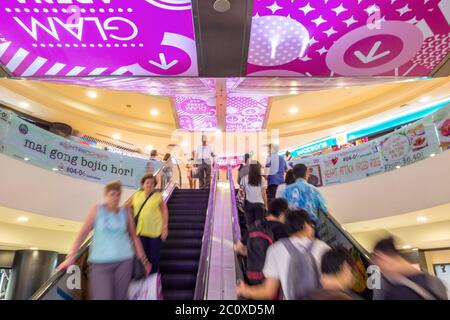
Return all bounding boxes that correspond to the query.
[320,142,383,185]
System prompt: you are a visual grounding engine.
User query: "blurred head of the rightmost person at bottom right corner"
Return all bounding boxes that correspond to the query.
[372,237,405,273]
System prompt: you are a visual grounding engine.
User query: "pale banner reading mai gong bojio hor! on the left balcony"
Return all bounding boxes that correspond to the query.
[0,109,156,188]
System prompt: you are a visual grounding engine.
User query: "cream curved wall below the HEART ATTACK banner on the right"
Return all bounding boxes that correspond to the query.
[321,151,450,223]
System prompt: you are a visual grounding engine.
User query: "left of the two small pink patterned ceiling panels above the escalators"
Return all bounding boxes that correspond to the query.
[175,96,217,131]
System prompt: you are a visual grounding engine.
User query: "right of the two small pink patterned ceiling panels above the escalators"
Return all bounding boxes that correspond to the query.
[226,96,269,131]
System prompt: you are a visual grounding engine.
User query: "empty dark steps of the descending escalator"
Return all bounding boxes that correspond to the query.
[160,189,209,300]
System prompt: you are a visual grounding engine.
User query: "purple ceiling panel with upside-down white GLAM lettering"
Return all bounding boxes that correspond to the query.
[0,0,198,77]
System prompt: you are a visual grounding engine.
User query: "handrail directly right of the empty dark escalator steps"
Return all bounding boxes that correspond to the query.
[194,165,219,300]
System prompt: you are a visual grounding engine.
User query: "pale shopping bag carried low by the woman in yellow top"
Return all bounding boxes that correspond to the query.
[128,273,163,300]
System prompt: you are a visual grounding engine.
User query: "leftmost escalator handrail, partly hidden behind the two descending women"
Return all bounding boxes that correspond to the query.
[30,157,181,300]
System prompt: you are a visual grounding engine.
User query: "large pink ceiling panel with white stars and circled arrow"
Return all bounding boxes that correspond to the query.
[247,0,450,77]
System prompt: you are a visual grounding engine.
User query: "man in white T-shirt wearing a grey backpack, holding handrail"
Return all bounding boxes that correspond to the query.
[236,210,330,300]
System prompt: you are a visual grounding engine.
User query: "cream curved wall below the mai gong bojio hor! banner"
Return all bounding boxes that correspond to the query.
[0,154,134,221]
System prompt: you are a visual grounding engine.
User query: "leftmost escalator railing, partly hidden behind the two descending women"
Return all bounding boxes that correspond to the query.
[30,158,182,300]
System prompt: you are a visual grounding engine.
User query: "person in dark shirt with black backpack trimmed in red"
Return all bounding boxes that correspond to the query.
[236,199,289,285]
